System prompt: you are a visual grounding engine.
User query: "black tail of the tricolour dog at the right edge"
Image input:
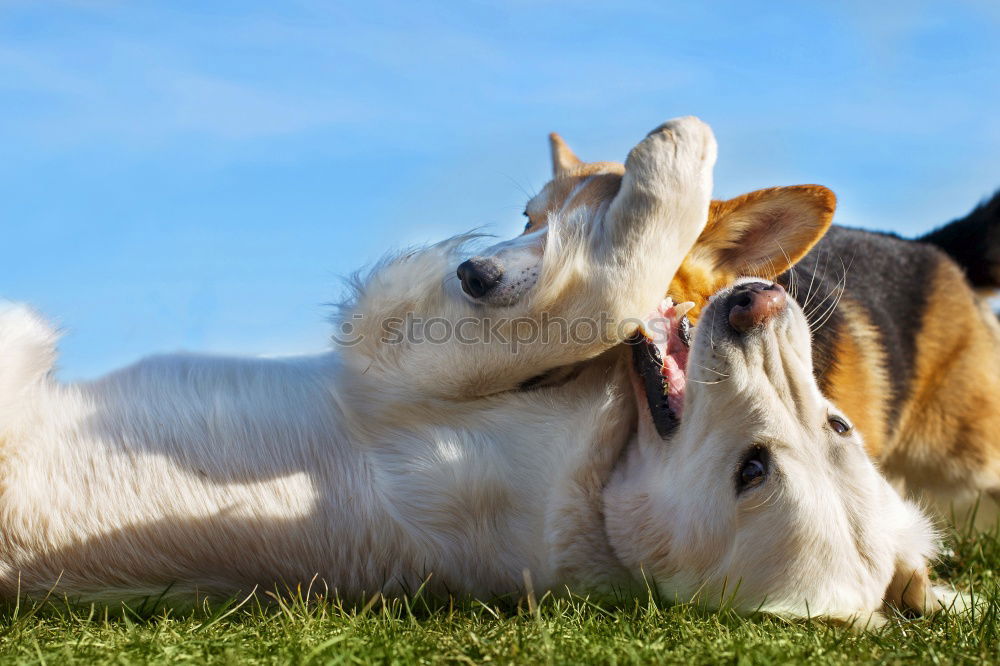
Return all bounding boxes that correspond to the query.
[917,190,1000,289]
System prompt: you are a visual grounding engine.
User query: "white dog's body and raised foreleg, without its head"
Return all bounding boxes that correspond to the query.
[0,118,715,599]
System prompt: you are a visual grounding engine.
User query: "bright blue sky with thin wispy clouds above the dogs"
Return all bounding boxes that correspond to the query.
[0,0,1000,379]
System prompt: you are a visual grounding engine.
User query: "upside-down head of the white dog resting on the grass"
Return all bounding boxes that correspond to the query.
[605,279,940,623]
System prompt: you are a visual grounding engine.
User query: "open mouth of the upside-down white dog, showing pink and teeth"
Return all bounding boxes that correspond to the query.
[629,298,694,439]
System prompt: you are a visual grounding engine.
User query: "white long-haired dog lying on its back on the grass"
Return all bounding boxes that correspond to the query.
[0,118,935,619]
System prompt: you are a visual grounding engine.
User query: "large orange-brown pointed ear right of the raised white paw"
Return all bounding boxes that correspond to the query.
[695,185,837,279]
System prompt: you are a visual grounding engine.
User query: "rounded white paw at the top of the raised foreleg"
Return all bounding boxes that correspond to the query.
[625,116,717,190]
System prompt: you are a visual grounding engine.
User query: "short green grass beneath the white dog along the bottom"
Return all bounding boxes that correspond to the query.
[0,520,1000,666]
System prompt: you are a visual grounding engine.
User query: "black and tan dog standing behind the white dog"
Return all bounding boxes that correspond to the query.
[525,134,1000,526]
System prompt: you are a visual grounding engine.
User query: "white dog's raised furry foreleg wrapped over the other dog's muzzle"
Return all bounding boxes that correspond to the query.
[344,117,716,400]
